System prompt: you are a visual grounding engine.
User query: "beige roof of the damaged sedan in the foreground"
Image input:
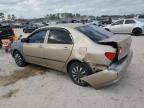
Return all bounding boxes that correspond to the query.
[42,23,84,29]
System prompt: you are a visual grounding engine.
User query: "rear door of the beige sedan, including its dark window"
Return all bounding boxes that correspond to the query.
[44,28,73,70]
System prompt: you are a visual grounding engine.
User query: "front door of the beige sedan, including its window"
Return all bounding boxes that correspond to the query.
[23,30,47,65]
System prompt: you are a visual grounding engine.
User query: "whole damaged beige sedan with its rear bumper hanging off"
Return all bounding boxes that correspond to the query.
[11,24,132,87]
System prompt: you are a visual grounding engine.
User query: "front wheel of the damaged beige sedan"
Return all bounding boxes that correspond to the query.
[14,51,27,67]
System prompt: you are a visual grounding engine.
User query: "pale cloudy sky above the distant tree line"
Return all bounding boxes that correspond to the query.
[0,0,144,18]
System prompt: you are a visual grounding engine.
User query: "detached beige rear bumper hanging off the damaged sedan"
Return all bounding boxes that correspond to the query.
[81,51,133,88]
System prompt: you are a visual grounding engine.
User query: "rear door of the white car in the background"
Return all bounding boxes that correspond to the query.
[123,19,136,33]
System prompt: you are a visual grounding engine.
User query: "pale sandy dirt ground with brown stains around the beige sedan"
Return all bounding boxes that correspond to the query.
[0,30,144,108]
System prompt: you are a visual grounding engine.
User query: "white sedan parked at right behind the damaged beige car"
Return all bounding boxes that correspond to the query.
[105,19,144,35]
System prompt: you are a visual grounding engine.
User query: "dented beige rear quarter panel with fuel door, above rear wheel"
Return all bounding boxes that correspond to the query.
[65,27,116,69]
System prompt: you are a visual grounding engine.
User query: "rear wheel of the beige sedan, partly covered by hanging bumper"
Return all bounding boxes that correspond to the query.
[68,62,91,86]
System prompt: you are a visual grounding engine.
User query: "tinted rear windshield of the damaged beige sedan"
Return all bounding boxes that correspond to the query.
[76,25,113,42]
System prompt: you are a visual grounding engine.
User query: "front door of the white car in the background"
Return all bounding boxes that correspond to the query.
[110,20,124,33]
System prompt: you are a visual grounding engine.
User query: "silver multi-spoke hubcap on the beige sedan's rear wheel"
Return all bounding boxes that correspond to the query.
[72,66,86,84]
